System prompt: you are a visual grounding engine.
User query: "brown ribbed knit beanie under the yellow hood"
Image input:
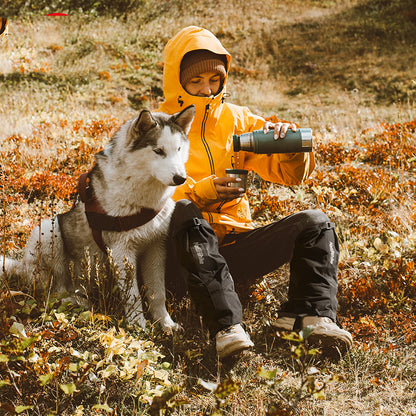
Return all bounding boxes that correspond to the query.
[180,49,227,87]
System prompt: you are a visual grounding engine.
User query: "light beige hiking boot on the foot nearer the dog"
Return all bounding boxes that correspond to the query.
[215,324,254,358]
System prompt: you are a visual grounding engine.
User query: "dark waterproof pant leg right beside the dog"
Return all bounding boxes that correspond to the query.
[166,200,242,336]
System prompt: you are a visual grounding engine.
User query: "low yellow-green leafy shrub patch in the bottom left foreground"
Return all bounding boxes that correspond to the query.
[0,292,179,415]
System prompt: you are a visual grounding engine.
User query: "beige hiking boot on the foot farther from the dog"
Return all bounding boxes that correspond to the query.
[302,316,352,354]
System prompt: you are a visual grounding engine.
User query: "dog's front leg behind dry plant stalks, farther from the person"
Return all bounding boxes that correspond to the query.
[112,246,146,328]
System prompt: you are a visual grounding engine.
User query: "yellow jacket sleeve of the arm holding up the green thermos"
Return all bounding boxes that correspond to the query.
[235,107,315,186]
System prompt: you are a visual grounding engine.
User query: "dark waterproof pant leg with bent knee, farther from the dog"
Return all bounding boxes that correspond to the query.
[220,210,339,321]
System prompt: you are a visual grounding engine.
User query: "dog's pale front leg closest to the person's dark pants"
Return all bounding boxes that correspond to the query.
[141,241,182,332]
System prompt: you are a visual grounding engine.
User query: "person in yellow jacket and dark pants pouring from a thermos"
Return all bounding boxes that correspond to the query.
[159,26,352,359]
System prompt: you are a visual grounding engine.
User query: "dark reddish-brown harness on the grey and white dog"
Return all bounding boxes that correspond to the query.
[78,171,160,254]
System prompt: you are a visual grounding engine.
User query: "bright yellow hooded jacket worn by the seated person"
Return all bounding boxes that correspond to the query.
[159,26,315,241]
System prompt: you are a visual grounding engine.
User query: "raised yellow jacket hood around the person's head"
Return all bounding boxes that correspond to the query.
[161,26,231,113]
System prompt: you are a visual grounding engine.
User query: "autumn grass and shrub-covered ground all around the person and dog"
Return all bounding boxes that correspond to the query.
[0,0,416,416]
